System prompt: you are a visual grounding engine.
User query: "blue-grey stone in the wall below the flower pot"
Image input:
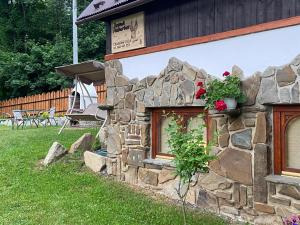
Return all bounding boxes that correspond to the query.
[231,129,252,150]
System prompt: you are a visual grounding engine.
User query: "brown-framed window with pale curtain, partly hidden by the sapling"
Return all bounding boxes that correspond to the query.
[152,107,206,158]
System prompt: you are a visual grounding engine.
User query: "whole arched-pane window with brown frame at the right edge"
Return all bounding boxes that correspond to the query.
[273,106,300,176]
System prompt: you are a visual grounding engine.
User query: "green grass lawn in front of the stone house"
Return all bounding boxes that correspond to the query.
[0,127,227,225]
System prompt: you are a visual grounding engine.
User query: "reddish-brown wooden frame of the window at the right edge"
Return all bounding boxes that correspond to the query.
[273,105,300,176]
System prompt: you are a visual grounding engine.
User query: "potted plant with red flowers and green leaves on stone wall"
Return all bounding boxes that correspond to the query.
[196,71,245,111]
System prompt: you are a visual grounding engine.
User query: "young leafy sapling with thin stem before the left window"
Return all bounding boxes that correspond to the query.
[166,114,215,224]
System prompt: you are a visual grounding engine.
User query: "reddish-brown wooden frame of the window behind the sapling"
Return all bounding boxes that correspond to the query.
[151,107,209,159]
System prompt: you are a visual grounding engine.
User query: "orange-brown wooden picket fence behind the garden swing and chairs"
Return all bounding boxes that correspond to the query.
[0,84,106,114]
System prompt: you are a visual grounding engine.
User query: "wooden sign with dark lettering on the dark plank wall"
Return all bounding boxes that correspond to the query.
[111,12,145,53]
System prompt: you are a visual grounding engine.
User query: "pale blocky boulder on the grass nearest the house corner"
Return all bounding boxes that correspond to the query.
[83,151,106,173]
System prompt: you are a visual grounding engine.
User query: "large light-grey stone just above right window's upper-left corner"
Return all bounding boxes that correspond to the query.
[258,77,279,104]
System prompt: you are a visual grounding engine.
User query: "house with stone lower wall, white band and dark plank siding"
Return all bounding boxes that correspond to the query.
[77,0,300,224]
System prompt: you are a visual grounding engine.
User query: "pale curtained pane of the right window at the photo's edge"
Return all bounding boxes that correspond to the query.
[286,118,300,169]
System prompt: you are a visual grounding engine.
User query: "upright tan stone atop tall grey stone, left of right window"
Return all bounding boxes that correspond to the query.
[253,112,267,144]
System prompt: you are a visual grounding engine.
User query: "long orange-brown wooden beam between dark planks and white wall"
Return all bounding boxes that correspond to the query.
[105,16,300,61]
